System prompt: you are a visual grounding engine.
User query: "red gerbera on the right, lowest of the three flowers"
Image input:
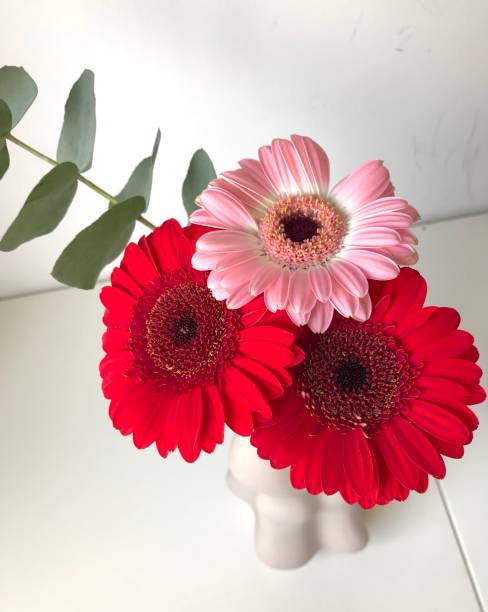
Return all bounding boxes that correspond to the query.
[251,268,486,508]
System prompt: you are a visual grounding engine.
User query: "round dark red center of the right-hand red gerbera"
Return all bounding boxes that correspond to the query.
[298,320,418,435]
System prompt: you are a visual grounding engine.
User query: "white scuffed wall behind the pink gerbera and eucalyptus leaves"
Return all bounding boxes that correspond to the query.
[0,0,488,296]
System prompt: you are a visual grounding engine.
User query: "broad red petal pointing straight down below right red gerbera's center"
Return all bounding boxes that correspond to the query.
[343,429,373,496]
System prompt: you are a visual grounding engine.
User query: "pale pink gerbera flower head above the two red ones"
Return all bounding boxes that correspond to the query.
[191,136,418,332]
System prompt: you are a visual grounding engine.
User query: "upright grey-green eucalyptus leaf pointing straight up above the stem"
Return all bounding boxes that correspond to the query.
[56,70,96,172]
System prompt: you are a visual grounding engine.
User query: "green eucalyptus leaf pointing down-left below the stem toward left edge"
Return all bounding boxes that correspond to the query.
[0,162,78,251]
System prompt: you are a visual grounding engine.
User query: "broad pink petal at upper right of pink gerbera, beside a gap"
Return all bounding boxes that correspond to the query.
[331,160,393,210]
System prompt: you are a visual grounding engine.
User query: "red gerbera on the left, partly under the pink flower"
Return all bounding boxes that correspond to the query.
[100,220,303,461]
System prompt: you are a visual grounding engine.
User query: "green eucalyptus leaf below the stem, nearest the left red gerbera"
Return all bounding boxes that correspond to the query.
[52,197,145,289]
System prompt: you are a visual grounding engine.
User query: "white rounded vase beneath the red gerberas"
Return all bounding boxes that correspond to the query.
[227,436,368,569]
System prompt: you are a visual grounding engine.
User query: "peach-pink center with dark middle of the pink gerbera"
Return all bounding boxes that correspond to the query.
[260,196,347,269]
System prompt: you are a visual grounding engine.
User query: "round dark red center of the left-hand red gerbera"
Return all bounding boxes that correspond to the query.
[130,271,240,388]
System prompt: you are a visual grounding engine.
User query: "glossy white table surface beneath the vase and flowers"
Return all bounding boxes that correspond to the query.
[0,216,488,612]
